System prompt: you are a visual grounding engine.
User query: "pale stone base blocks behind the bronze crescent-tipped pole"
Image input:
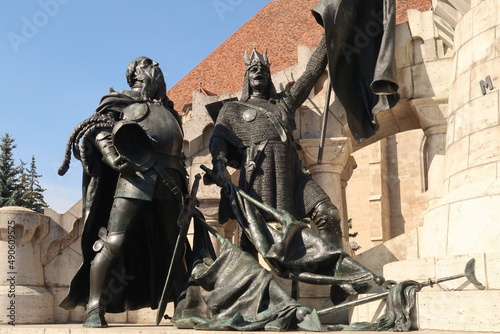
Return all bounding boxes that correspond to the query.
[350,252,500,333]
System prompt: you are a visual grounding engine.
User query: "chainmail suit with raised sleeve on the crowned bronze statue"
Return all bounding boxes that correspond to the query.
[210,39,329,219]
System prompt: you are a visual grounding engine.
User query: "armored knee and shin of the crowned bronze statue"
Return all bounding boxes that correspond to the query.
[311,201,342,249]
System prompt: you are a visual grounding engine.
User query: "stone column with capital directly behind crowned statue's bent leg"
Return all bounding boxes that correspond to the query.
[299,137,352,247]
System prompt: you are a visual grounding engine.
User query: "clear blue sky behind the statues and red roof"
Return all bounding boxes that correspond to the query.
[0,0,270,213]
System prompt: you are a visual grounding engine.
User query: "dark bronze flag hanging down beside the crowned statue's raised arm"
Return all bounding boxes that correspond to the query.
[312,0,399,142]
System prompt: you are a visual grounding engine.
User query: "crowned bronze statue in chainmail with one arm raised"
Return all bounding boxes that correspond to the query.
[210,39,342,248]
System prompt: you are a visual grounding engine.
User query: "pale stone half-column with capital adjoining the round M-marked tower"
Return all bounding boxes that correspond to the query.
[410,97,448,206]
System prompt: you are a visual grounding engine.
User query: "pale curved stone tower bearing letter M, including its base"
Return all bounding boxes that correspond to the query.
[352,0,500,333]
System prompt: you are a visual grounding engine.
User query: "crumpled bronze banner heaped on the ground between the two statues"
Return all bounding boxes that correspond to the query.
[172,219,310,331]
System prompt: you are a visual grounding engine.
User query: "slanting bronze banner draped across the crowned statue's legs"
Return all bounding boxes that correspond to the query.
[225,181,376,285]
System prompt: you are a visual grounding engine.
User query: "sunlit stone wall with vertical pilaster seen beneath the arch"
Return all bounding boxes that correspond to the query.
[347,130,428,254]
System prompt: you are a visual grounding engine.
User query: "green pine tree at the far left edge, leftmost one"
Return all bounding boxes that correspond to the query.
[0,133,22,207]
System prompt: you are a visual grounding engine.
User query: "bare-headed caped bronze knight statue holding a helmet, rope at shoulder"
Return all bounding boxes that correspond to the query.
[59,57,187,327]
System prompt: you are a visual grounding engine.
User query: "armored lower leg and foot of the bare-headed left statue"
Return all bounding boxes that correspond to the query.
[83,229,125,328]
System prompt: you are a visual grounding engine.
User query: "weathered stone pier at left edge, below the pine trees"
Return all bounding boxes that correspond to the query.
[0,207,54,324]
